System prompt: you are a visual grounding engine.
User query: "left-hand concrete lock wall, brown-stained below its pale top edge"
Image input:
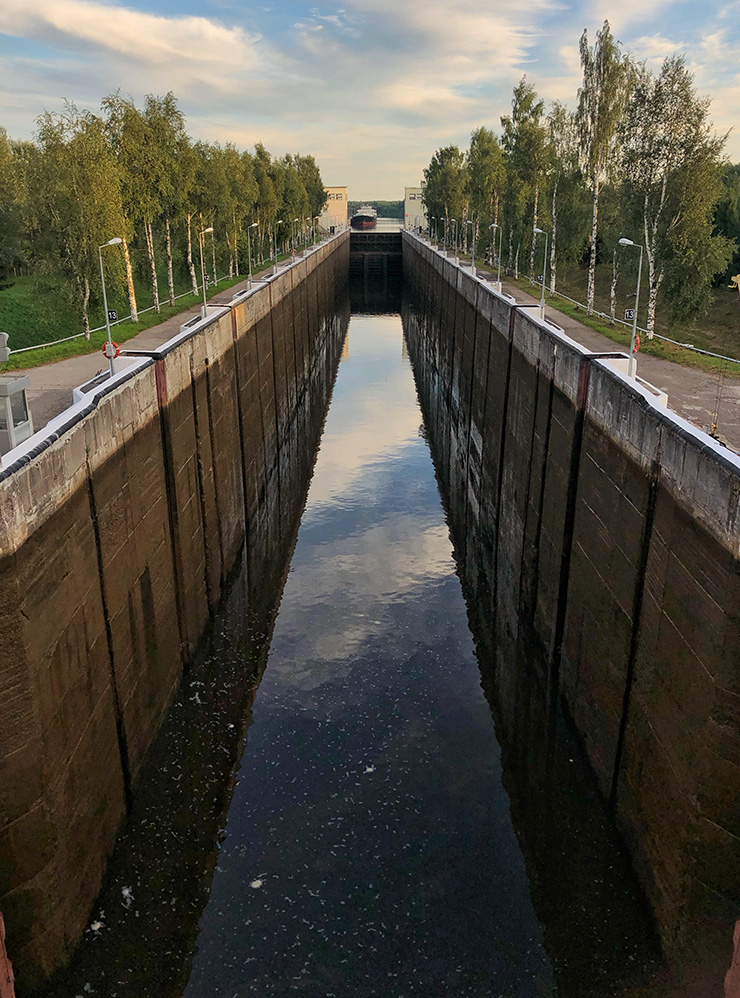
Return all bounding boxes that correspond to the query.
[0,233,349,985]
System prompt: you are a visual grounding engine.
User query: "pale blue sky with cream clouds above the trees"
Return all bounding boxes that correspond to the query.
[0,0,740,200]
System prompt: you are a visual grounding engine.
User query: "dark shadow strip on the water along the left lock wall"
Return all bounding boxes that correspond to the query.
[31,301,349,998]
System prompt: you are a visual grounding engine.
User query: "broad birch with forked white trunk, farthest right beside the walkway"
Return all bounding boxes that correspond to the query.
[622,56,733,337]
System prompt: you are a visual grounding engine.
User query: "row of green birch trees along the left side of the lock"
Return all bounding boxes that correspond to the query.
[0,92,326,334]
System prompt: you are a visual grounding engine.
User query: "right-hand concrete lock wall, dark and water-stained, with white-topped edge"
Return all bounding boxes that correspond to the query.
[403,233,740,952]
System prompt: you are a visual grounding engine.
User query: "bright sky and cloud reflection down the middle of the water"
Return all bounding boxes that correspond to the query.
[185,308,553,998]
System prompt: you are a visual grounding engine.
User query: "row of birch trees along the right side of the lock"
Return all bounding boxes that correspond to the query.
[424,21,740,336]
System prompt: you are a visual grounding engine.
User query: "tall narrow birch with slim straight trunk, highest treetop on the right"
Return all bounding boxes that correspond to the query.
[576,21,632,315]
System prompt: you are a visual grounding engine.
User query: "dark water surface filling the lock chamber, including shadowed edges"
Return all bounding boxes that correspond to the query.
[33,289,657,998]
